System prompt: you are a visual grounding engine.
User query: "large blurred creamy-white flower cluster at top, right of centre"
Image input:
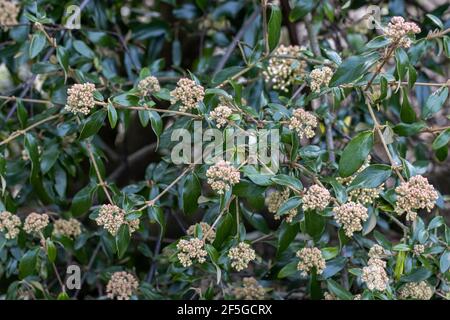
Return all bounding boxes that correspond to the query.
[263,45,307,92]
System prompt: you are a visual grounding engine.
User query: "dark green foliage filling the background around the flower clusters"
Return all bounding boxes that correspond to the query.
[0,0,450,299]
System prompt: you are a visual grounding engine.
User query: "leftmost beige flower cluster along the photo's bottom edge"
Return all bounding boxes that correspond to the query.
[106,271,139,300]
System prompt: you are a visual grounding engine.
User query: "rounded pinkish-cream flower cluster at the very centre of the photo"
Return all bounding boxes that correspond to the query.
[206,160,240,194]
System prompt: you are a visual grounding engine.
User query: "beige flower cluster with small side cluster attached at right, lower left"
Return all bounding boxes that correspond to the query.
[95,204,139,236]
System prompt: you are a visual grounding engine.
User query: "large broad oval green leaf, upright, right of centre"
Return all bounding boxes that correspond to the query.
[339,131,373,177]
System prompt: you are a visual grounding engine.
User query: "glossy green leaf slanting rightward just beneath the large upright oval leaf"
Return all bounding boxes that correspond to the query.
[348,164,392,190]
